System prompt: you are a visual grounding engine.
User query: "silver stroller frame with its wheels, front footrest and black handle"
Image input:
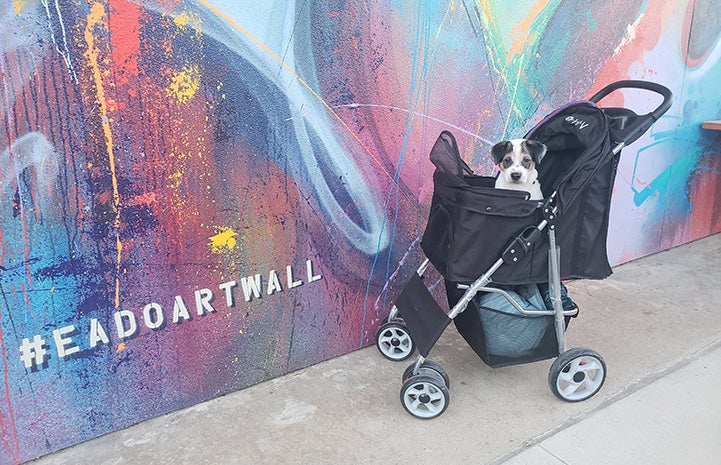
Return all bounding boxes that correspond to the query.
[376,81,672,419]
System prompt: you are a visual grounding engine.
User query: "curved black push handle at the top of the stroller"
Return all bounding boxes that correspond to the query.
[589,80,673,145]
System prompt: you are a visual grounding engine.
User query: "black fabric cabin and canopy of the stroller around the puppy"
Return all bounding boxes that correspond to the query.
[421,102,618,284]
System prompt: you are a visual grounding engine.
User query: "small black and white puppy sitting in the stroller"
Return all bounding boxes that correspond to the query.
[491,139,546,200]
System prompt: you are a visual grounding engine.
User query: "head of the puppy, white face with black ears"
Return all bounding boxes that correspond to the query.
[491,139,546,184]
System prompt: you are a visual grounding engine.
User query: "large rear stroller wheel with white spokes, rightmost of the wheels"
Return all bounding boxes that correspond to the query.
[548,349,606,402]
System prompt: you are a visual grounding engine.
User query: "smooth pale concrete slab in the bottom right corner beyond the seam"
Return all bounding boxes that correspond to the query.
[503,347,721,465]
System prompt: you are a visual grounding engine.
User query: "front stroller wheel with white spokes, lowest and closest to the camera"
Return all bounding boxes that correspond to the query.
[401,375,451,420]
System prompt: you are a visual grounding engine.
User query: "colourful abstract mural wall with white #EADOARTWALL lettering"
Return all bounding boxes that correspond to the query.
[0,0,721,464]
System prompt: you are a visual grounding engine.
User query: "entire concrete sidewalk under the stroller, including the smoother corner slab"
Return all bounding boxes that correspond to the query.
[32,235,721,465]
